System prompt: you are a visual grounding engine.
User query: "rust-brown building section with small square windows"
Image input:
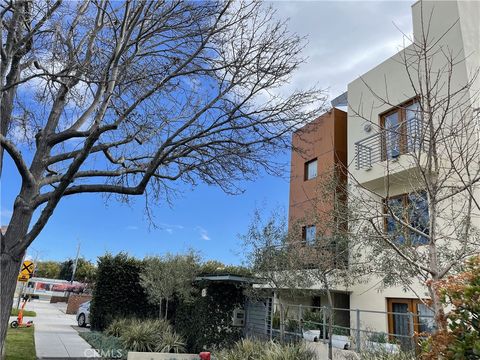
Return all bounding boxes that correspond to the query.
[283,108,350,323]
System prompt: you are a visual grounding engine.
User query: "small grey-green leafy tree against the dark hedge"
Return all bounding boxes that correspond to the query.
[140,251,199,319]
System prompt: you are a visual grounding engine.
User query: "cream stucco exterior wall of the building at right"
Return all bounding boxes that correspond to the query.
[348,1,480,332]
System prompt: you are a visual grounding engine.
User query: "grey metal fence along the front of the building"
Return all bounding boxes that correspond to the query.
[246,304,434,352]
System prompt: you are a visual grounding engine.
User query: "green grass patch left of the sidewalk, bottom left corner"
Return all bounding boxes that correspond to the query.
[6,326,36,360]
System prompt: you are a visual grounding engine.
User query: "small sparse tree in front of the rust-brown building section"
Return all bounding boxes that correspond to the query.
[289,172,370,359]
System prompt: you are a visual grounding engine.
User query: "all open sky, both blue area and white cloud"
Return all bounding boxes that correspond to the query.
[0,1,413,264]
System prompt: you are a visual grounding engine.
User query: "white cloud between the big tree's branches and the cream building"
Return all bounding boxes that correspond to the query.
[271,1,413,98]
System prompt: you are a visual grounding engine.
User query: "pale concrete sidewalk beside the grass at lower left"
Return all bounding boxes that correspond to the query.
[26,300,100,360]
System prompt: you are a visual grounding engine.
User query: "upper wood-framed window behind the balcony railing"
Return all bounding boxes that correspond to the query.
[380,100,423,160]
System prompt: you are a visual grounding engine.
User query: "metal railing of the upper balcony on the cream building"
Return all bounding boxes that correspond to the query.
[355,118,425,170]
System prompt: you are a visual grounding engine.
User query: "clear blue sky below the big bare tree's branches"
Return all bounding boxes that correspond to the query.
[1,149,288,264]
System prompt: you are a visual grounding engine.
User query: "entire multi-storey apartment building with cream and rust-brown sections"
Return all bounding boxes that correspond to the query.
[285,1,480,335]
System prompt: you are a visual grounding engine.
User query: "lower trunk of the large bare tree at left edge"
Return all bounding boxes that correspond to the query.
[0,255,23,359]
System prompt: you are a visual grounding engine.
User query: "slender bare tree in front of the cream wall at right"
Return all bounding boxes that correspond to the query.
[349,3,480,334]
